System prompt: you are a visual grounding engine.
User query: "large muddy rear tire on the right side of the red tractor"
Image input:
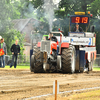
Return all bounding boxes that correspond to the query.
[61,45,76,73]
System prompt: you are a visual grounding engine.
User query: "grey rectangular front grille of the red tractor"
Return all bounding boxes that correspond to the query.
[40,41,51,53]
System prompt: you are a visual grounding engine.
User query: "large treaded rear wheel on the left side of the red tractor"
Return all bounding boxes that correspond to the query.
[30,46,43,73]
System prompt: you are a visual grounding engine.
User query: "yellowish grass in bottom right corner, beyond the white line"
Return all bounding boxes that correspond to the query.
[50,90,100,100]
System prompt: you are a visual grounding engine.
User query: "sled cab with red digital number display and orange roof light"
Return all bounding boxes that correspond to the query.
[68,12,92,37]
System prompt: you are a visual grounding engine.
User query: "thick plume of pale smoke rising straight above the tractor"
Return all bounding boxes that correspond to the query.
[43,0,60,31]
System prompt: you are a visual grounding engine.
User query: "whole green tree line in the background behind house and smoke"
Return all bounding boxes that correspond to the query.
[0,0,100,54]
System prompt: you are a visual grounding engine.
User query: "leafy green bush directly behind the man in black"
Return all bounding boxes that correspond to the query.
[1,29,25,55]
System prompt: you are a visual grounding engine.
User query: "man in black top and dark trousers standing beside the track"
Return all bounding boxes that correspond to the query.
[10,40,20,68]
